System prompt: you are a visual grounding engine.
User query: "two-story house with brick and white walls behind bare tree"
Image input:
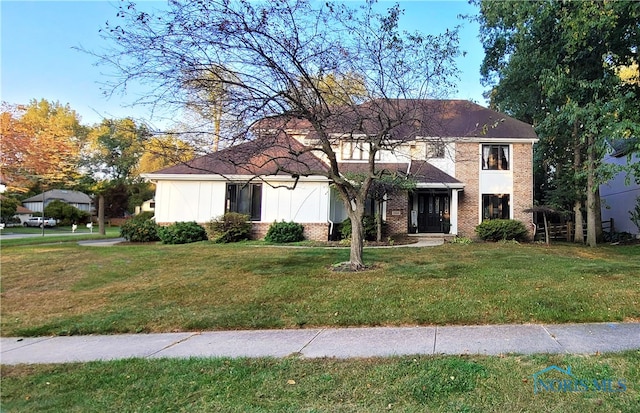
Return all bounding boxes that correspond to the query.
[144,100,537,240]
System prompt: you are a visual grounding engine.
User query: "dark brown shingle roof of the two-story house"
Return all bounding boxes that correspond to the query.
[152,100,536,179]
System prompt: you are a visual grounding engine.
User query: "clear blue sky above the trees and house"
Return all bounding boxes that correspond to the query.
[0,0,485,125]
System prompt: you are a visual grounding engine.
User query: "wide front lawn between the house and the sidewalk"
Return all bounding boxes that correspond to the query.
[0,242,640,336]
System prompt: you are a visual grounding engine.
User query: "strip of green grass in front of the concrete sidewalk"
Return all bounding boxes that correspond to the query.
[1,351,640,413]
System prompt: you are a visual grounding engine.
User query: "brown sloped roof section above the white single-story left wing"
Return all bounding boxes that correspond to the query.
[149,132,327,176]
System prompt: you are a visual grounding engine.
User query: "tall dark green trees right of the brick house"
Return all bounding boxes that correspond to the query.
[474,0,640,246]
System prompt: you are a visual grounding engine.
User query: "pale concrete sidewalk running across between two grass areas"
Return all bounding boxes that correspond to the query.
[0,323,640,364]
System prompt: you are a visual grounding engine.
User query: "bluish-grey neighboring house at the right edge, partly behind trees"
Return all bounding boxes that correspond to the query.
[600,140,640,234]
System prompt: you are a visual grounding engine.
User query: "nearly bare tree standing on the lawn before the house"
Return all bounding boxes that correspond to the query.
[98,0,458,270]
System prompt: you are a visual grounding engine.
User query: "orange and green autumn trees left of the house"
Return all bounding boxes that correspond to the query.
[0,99,193,232]
